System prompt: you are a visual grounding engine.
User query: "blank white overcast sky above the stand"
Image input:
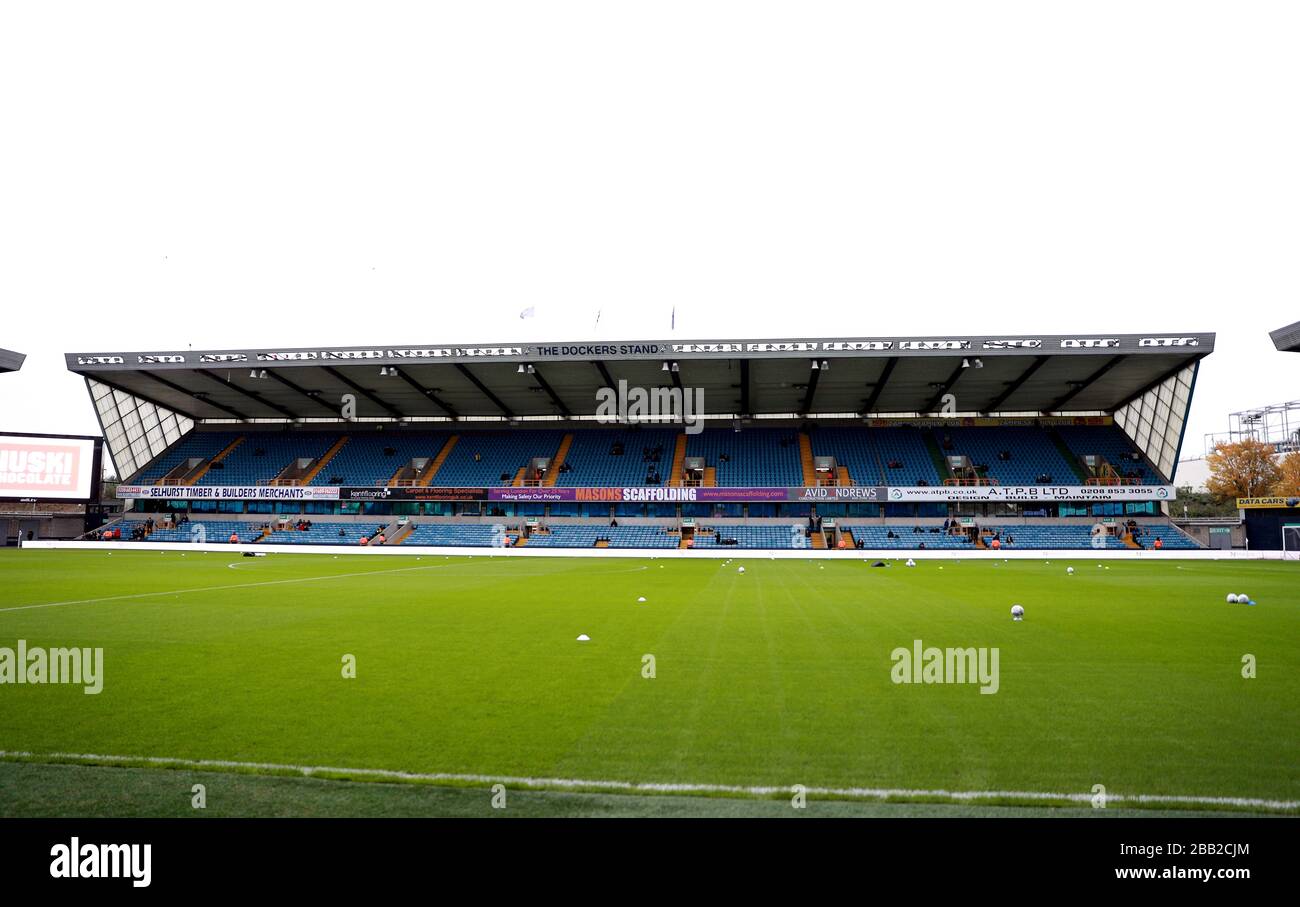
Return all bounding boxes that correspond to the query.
[0,0,1300,465]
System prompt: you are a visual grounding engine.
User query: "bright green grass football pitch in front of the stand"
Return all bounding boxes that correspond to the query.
[0,550,1300,815]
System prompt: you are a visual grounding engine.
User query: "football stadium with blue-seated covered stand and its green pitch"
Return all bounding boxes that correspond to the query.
[0,333,1300,816]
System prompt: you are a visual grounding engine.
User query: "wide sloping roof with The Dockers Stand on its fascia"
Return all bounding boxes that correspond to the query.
[66,331,1214,421]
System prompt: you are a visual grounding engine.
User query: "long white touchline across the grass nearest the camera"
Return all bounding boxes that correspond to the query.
[0,750,1300,810]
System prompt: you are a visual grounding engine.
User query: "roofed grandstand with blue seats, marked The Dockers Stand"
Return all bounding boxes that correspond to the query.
[68,334,1214,551]
